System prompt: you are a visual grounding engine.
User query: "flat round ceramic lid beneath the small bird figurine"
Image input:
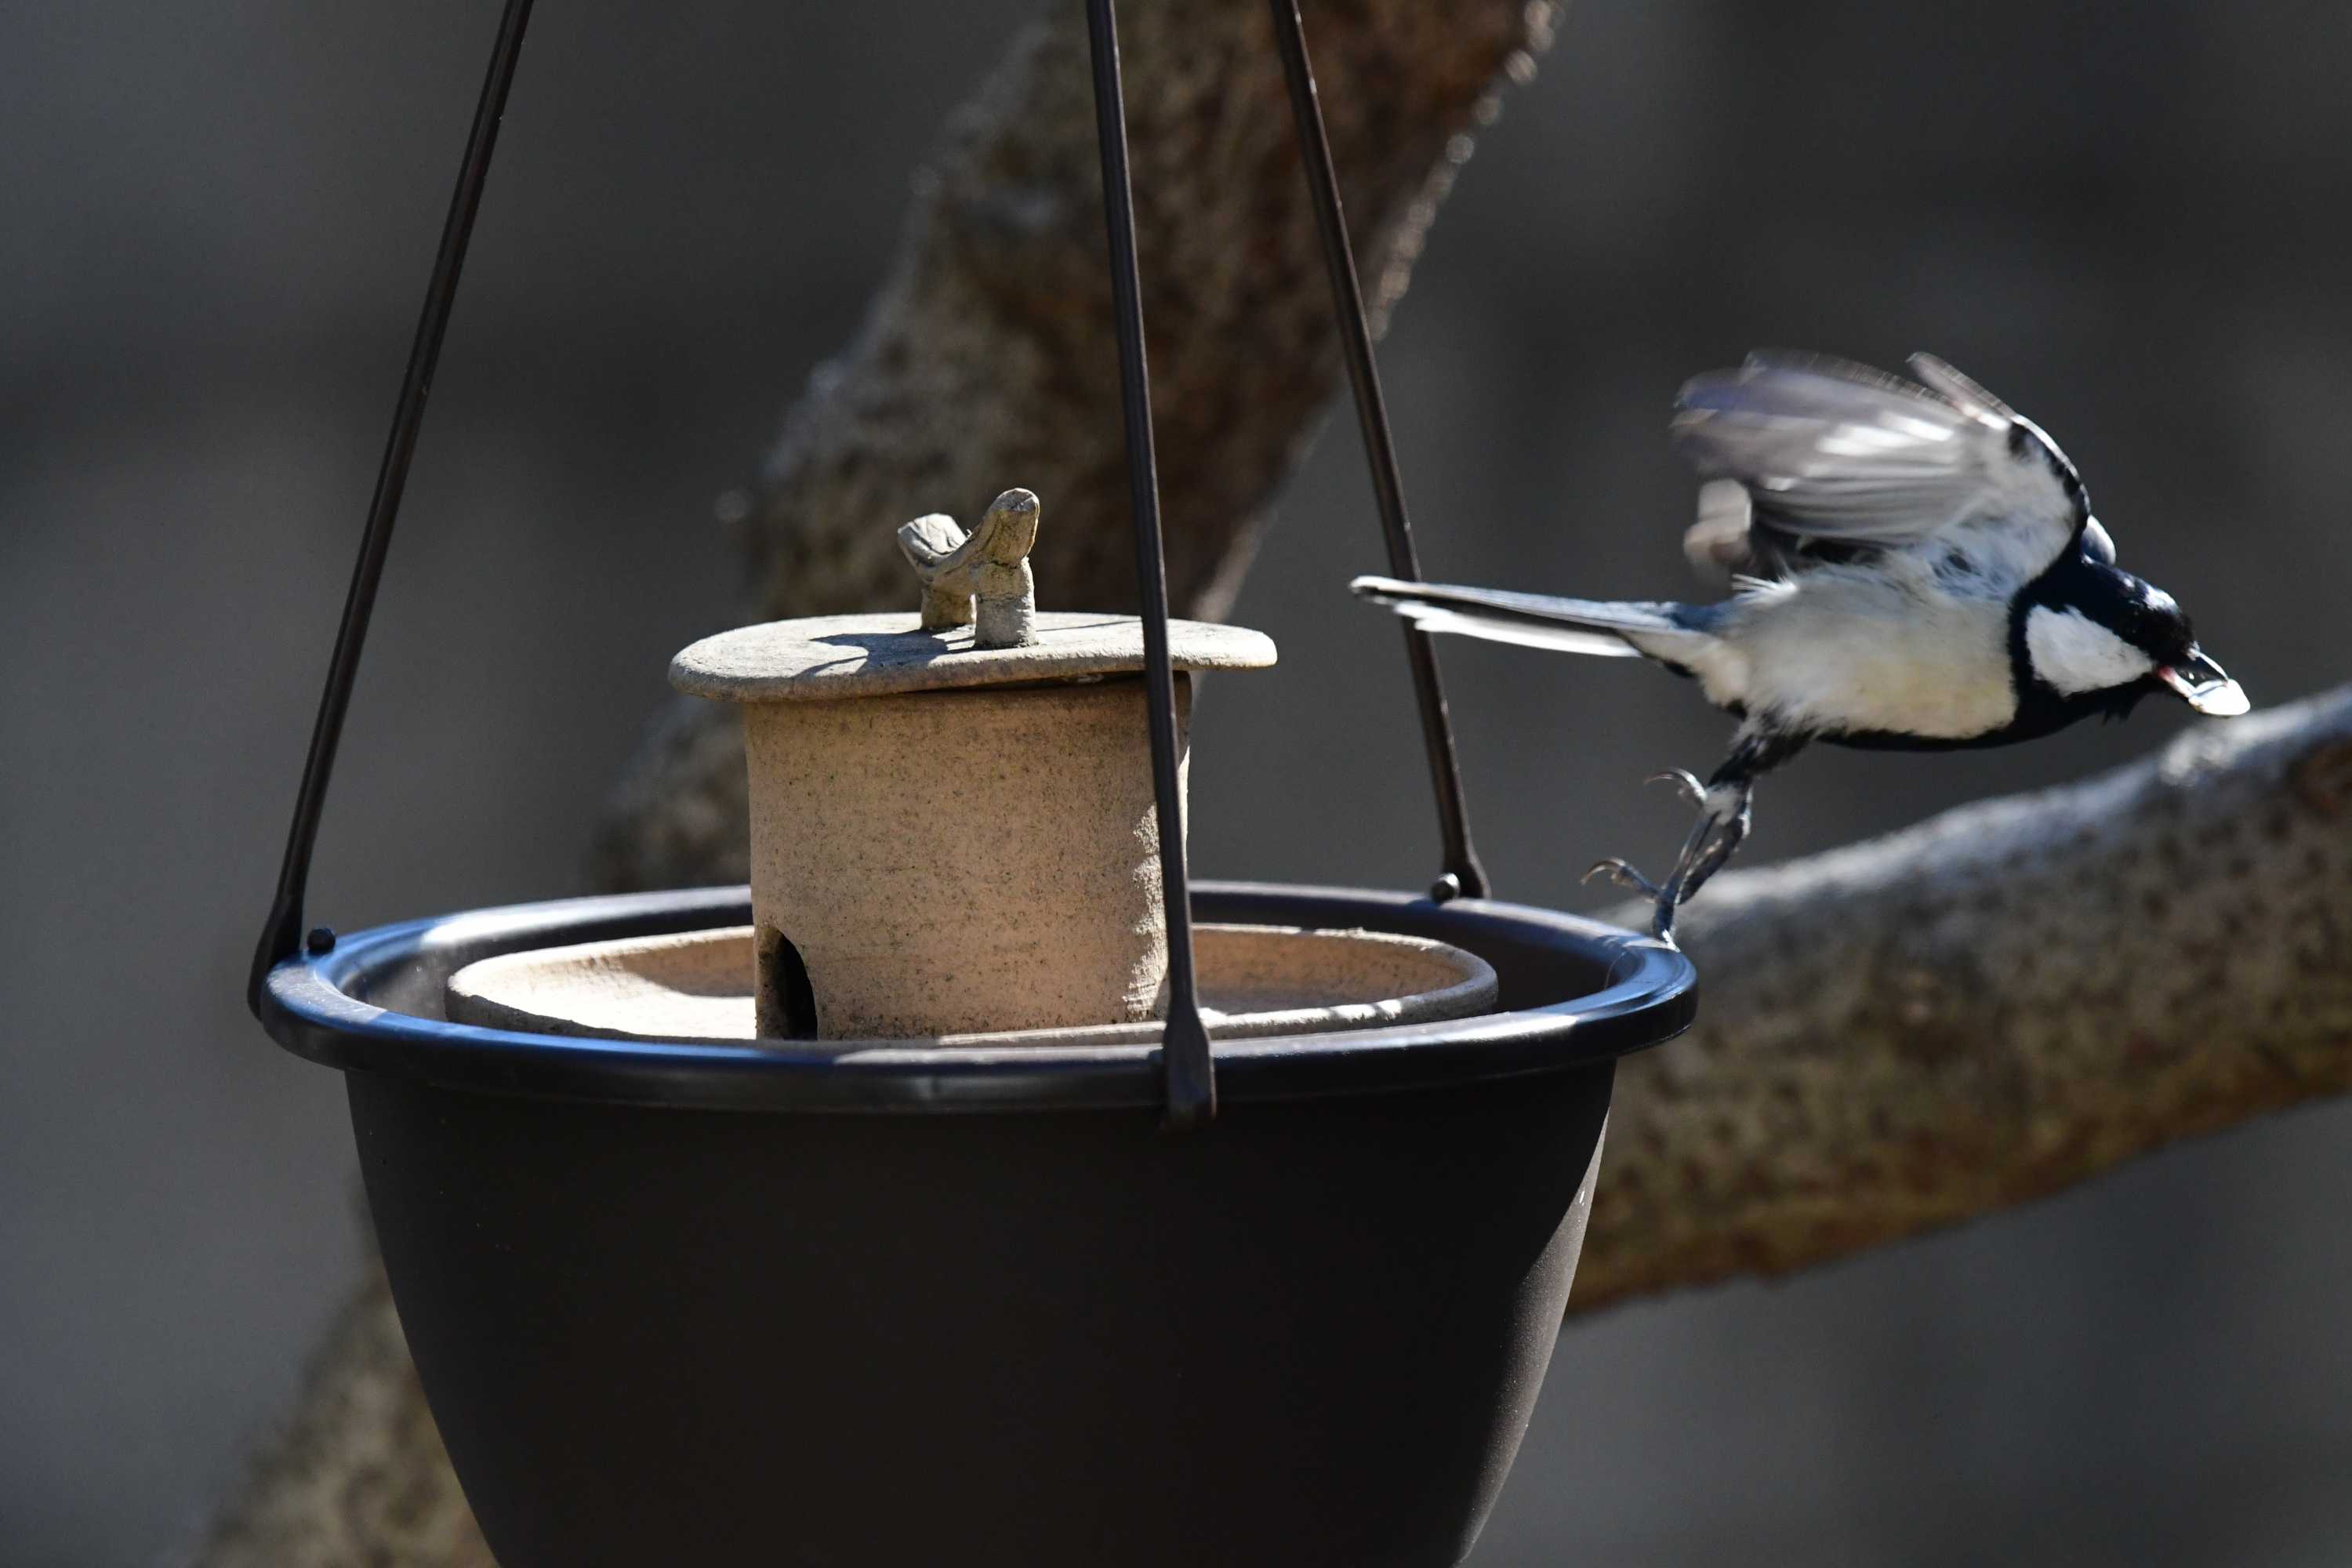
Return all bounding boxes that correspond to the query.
[670,612,1275,703]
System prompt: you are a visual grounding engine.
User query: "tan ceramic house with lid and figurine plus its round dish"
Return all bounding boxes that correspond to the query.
[447,489,1496,1048]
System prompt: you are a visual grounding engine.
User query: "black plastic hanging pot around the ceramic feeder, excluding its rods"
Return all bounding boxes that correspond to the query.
[263,884,1693,1568]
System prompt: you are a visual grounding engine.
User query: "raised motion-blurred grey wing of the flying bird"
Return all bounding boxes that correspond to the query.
[1672,355,2089,576]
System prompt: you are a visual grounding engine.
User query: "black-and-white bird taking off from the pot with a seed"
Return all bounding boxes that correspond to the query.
[1352,353,2249,945]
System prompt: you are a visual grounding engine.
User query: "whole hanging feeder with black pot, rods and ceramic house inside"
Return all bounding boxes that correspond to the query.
[249,0,1693,1568]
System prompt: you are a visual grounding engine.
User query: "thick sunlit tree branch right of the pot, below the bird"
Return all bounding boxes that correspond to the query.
[1573,687,2352,1312]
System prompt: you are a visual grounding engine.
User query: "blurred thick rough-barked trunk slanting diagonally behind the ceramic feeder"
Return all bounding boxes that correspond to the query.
[198,0,1555,1568]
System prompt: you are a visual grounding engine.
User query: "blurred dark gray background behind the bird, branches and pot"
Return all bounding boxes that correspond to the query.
[0,0,2352,1568]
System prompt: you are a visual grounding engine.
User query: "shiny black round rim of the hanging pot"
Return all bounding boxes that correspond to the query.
[259,881,1698,1114]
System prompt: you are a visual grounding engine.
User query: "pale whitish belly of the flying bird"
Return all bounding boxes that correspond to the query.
[1700,572,2018,741]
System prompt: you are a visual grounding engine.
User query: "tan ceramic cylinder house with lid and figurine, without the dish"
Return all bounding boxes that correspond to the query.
[670,489,1275,1039]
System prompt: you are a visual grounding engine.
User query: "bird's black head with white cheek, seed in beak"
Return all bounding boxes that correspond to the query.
[2016,545,2246,717]
